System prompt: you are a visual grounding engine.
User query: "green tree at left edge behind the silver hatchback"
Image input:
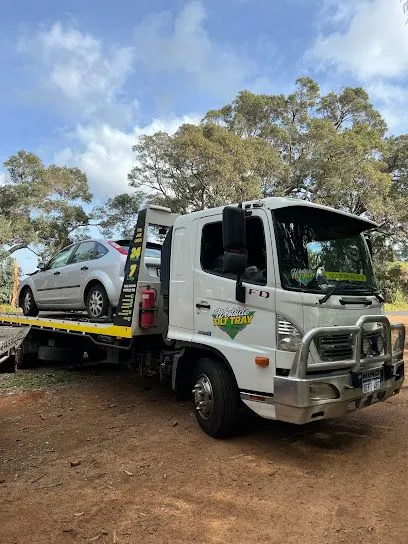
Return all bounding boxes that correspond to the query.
[0,150,92,257]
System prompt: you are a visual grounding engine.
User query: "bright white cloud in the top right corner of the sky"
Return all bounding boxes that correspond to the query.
[306,0,408,81]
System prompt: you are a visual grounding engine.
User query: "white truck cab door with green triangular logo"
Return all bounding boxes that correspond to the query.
[194,209,276,392]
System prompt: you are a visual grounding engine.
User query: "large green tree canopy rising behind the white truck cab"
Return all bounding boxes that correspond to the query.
[122,78,408,255]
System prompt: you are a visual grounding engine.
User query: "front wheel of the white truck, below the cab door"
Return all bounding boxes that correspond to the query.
[193,358,240,438]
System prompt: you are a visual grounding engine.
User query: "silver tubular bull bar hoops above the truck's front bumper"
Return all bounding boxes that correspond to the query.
[289,315,405,380]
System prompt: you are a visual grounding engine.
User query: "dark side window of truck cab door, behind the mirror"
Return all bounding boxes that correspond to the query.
[201,217,266,285]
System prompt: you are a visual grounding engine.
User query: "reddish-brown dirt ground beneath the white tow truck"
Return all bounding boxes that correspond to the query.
[0,318,408,544]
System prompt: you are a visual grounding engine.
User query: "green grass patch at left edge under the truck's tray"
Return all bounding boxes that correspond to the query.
[0,368,74,393]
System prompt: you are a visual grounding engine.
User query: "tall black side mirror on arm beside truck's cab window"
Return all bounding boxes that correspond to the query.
[222,206,248,303]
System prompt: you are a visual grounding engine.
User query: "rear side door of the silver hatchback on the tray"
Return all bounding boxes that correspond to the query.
[62,240,101,309]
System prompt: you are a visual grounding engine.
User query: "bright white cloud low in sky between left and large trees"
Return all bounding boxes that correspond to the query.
[54,114,201,200]
